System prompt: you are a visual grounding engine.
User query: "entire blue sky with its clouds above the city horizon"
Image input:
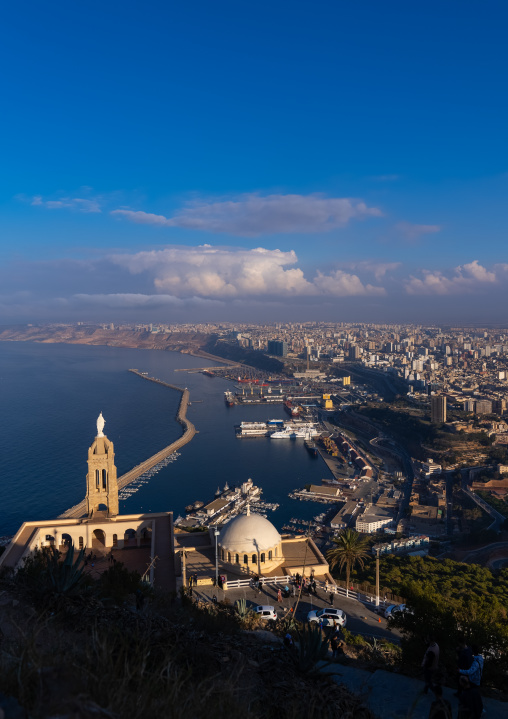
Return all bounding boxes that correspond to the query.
[0,0,508,323]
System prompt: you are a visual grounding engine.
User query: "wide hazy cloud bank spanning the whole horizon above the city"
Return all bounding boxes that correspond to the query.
[0,239,508,322]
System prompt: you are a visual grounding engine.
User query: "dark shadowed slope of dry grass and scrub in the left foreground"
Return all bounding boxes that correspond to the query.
[0,584,378,719]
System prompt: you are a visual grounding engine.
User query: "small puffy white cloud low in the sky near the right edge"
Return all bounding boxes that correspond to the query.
[404,260,497,295]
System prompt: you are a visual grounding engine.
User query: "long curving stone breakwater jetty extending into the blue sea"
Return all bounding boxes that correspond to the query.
[60,369,196,519]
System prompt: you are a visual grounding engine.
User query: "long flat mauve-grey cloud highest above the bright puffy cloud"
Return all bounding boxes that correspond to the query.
[111,193,382,237]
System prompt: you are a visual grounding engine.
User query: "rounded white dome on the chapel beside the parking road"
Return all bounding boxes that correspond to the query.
[218,514,281,554]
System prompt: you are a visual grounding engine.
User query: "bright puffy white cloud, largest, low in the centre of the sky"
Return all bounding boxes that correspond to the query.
[110,245,384,299]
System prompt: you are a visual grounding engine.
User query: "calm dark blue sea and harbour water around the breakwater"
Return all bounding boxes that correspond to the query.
[0,342,329,535]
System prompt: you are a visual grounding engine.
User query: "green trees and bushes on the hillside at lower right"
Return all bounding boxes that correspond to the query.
[350,555,508,691]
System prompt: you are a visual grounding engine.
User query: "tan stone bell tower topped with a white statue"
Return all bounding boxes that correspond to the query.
[86,412,118,518]
